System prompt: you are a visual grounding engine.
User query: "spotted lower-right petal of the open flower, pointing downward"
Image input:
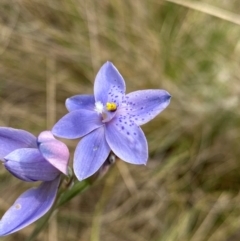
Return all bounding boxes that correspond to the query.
[105,117,148,165]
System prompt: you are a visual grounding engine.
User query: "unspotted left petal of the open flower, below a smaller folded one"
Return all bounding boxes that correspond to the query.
[52,110,103,139]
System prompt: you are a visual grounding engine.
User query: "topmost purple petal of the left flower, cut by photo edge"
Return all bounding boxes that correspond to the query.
[0,127,37,159]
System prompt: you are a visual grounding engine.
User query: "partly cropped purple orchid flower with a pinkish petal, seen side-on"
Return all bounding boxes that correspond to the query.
[0,127,69,236]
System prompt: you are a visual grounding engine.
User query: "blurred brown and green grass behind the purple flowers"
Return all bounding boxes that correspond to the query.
[0,0,240,241]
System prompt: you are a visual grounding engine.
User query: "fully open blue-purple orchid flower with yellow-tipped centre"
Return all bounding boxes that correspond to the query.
[52,62,171,180]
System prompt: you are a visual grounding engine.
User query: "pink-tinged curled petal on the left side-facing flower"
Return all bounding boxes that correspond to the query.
[38,131,69,175]
